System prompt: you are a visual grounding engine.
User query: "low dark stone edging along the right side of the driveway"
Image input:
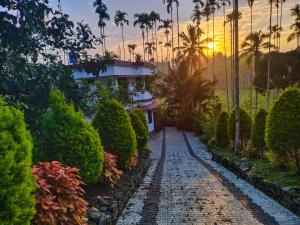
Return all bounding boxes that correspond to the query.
[212,152,300,216]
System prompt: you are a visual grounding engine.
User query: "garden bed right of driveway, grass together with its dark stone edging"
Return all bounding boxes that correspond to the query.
[212,149,300,216]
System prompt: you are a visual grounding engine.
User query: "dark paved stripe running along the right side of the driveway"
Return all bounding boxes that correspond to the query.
[182,131,278,225]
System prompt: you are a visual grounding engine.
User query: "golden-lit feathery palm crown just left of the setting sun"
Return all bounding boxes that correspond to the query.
[176,25,207,71]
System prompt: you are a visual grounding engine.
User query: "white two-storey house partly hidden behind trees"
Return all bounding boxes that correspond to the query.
[74,60,158,133]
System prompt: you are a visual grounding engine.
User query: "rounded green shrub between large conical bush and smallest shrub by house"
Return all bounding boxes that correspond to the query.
[92,99,137,168]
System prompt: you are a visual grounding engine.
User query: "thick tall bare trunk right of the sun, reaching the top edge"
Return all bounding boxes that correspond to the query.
[234,0,240,153]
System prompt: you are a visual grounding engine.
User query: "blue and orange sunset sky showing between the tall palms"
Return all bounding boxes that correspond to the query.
[50,0,299,56]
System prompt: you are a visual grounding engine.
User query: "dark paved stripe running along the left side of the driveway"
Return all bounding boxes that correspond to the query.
[140,129,166,225]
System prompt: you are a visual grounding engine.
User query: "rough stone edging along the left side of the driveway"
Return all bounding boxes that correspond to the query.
[88,154,150,225]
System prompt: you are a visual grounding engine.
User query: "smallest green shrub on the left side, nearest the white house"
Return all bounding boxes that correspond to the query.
[129,109,149,151]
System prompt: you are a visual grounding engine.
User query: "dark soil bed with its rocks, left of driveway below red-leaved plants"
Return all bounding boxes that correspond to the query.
[86,154,150,225]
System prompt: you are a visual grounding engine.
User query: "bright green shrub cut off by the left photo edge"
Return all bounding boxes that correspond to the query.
[0,99,35,225]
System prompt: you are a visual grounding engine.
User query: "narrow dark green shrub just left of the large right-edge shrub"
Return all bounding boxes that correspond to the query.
[251,109,268,156]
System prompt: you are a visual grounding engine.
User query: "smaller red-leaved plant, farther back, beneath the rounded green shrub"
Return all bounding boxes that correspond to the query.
[103,152,123,185]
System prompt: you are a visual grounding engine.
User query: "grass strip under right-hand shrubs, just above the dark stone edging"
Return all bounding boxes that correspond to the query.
[215,148,300,188]
